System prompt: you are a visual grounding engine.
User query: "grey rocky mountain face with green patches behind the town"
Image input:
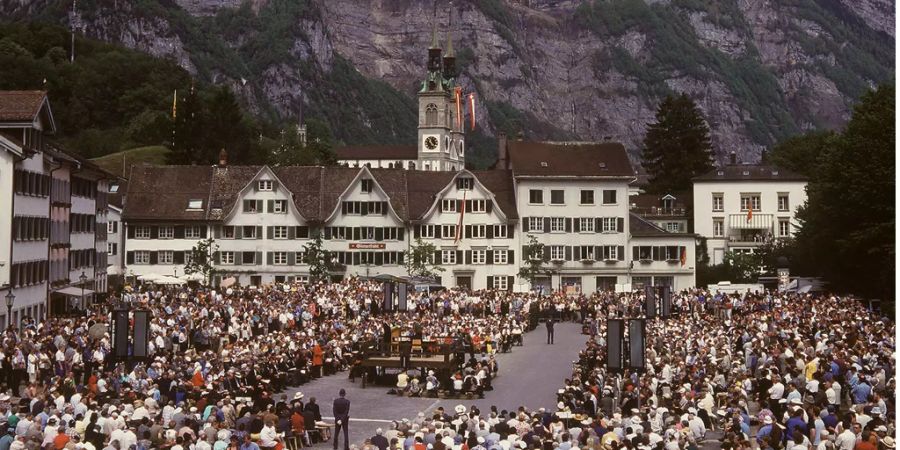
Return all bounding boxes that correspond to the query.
[0,0,894,167]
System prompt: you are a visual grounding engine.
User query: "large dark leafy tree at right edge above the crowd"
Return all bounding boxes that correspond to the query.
[796,85,896,300]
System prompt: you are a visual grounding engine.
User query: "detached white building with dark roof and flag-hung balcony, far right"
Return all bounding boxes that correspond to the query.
[693,164,807,264]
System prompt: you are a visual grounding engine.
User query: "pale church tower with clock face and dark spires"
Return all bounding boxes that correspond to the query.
[417,18,466,171]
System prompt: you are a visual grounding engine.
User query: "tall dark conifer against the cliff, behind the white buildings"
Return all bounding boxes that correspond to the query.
[641,94,713,194]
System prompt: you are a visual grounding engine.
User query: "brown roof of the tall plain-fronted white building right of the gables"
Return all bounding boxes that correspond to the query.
[506,141,634,178]
